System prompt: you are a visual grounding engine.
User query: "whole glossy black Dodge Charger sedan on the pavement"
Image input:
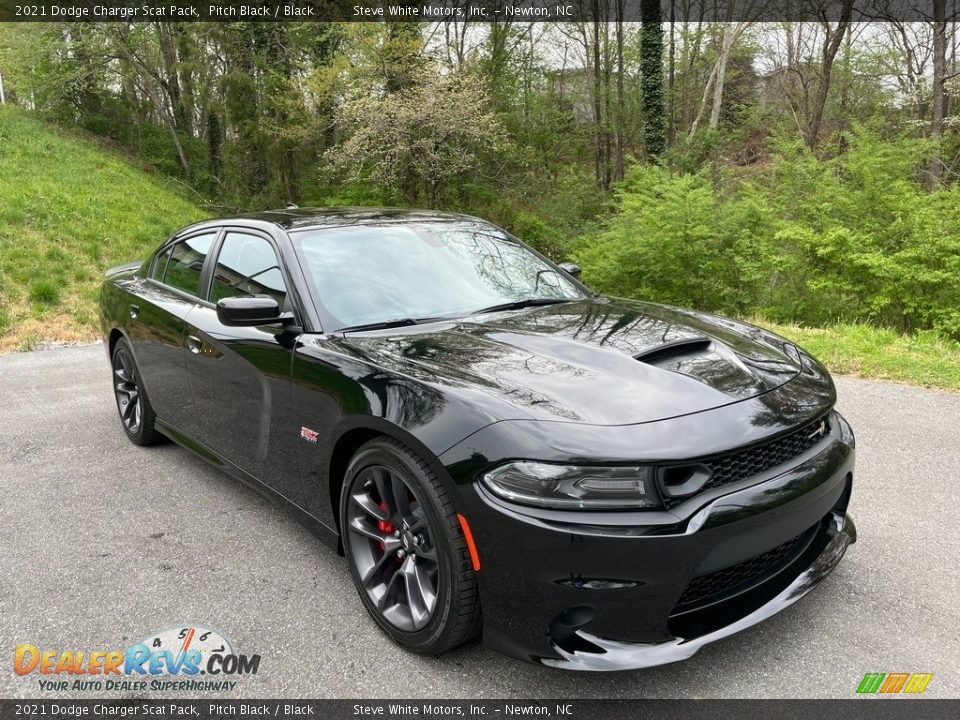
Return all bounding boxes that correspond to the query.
[101,209,856,670]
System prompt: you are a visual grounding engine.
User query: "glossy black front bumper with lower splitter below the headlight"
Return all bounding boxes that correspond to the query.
[442,413,856,670]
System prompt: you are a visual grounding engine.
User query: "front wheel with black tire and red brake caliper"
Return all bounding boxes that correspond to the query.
[340,438,481,655]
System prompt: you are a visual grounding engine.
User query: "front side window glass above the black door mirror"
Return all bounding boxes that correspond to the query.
[210,232,287,308]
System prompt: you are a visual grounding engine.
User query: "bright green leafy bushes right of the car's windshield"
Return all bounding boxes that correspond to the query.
[573,130,960,337]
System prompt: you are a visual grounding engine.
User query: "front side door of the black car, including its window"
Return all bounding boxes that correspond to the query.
[187,228,302,502]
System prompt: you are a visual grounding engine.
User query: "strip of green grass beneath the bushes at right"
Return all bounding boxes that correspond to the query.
[757,320,960,390]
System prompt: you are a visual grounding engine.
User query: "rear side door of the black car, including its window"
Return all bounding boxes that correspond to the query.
[127,229,217,435]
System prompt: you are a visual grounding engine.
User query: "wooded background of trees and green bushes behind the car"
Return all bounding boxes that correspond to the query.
[0,6,960,338]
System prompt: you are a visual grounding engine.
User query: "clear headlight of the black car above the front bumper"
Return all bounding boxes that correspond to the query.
[481,461,660,510]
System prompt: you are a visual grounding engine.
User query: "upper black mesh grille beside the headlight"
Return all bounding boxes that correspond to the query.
[663,418,830,509]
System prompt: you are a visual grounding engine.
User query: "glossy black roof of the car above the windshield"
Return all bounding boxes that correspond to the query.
[177,207,488,235]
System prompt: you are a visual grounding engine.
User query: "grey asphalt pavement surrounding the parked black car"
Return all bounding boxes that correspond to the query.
[0,345,960,698]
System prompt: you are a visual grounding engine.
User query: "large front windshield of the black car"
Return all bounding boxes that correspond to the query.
[291,223,586,332]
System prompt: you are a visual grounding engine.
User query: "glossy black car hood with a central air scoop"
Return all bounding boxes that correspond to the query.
[342,297,801,425]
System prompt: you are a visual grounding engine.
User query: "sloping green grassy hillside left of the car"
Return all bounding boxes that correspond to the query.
[0,106,204,352]
